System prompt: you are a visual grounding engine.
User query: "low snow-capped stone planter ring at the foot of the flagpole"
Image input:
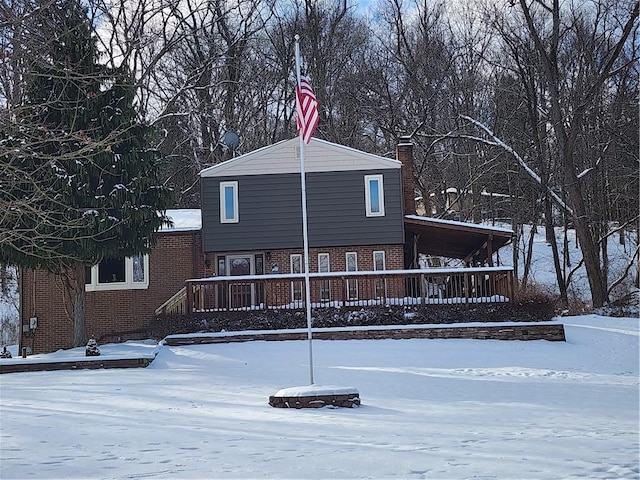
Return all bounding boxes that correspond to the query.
[269,385,360,408]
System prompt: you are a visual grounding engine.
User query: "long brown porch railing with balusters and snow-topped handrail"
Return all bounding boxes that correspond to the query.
[170,267,514,314]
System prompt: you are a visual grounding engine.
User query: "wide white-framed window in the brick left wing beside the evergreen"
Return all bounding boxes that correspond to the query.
[85,255,149,292]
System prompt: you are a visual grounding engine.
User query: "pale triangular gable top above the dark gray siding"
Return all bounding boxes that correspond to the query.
[200,137,402,178]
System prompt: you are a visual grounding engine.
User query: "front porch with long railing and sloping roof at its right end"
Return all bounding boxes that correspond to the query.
[156,215,515,315]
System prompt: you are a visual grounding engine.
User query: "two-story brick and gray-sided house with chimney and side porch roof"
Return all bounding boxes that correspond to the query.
[20,138,512,352]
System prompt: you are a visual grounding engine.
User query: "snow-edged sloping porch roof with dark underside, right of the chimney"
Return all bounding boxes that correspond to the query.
[404,215,513,263]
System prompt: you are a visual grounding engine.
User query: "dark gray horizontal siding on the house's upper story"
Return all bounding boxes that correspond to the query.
[201,169,404,252]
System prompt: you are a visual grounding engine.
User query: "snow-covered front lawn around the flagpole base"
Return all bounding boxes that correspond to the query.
[0,315,640,480]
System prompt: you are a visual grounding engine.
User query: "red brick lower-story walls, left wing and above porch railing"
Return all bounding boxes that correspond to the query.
[20,230,404,353]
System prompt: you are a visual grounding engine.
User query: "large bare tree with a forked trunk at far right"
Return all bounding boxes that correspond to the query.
[519,0,638,307]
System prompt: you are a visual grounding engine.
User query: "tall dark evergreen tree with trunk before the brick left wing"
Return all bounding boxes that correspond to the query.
[0,0,171,346]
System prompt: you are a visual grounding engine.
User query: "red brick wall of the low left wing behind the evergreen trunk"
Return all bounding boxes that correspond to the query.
[21,231,205,353]
